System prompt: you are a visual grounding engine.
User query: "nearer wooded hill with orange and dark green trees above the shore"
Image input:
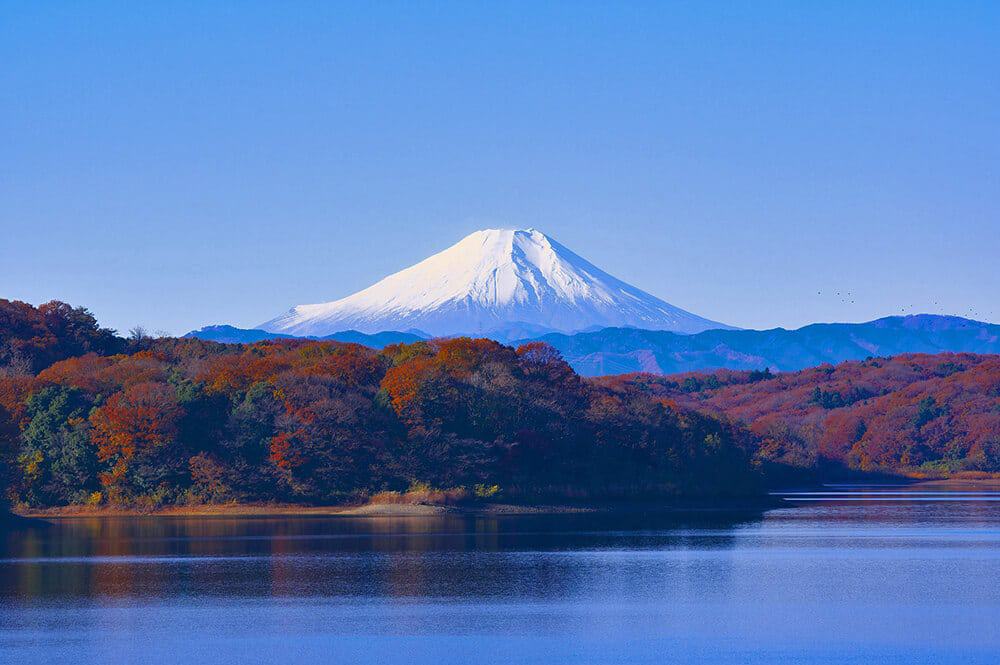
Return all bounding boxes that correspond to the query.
[0,300,760,508]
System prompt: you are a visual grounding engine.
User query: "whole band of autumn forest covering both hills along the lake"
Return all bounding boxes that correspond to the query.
[0,300,1000,510]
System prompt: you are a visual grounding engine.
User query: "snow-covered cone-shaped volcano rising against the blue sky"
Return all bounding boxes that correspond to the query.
[259,229,732,338]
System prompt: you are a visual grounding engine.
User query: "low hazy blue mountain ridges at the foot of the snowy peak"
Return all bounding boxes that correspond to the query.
[186,314,1000,376]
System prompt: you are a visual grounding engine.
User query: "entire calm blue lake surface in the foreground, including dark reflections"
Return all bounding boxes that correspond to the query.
[0,487,1000,665]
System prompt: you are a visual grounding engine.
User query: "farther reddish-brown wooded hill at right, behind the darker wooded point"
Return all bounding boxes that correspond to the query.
[596,353,1000,475]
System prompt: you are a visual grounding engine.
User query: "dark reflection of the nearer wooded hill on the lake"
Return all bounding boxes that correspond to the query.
[0,511,760,599]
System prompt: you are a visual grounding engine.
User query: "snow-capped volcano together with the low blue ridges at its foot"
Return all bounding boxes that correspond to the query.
[187,229,1000,376]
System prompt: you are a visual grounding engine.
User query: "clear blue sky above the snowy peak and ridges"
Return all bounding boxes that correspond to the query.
[0,0,1000,333]
